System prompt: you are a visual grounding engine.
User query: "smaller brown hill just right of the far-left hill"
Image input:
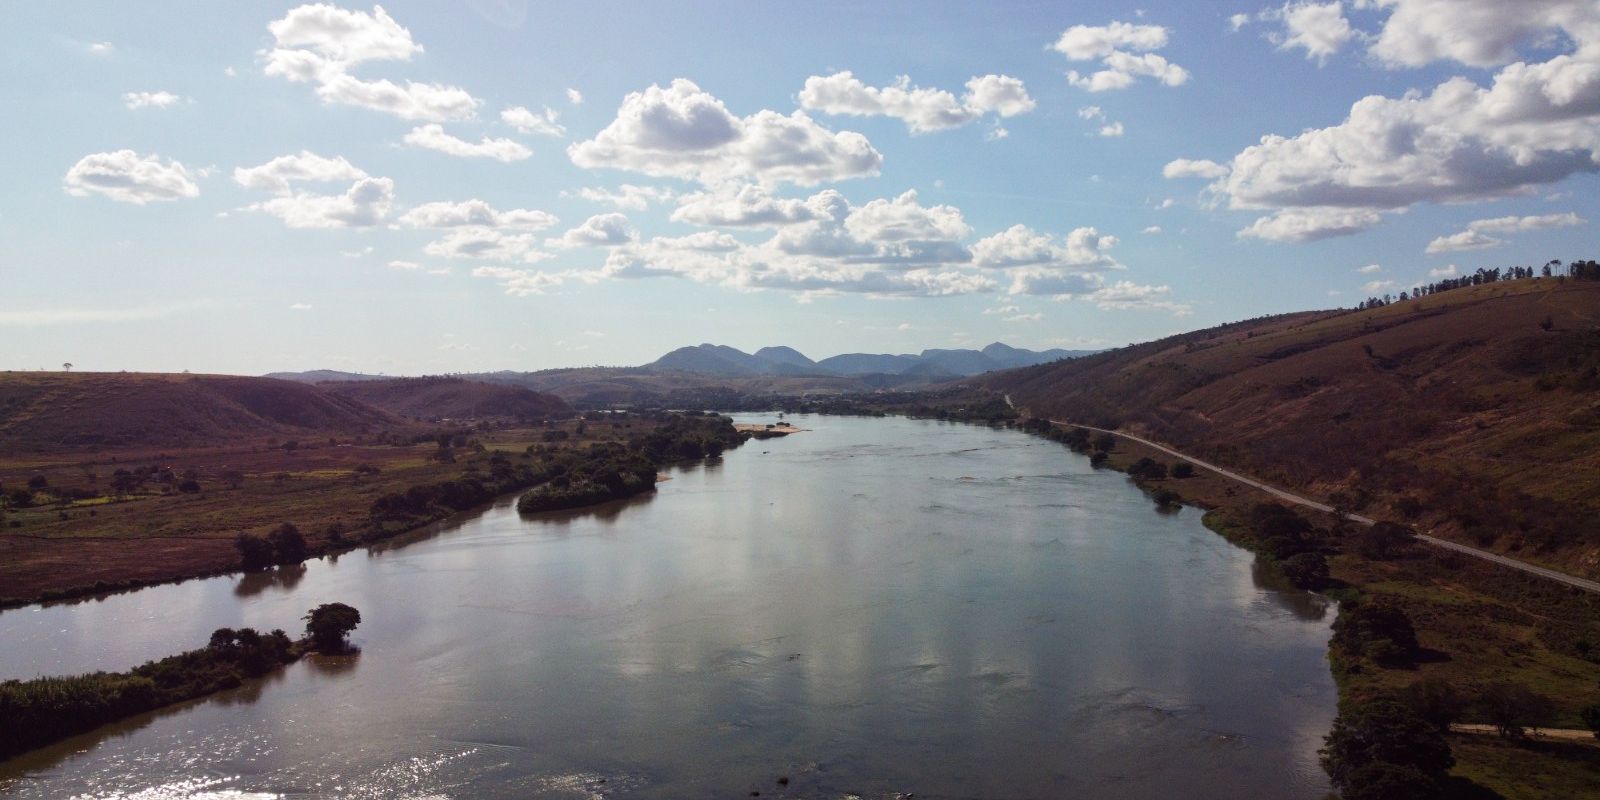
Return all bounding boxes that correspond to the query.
[318,378,573,419]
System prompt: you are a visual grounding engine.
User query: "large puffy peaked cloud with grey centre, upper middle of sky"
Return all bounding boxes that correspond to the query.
[566,78,883,186]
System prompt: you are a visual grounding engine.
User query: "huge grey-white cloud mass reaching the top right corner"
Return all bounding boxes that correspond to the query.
[1210,0,1600,240]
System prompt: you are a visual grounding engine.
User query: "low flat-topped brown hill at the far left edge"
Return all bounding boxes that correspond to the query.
[0,373,400,454]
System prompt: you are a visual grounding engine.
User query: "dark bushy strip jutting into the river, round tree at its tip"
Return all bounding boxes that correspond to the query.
[0,603,362,758]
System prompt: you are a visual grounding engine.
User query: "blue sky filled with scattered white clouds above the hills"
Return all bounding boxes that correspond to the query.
[0,0,1600,374]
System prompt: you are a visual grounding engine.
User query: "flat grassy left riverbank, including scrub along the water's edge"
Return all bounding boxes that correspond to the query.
[0,414,742,610]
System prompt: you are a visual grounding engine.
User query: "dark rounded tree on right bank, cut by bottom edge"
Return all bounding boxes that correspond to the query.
[1320,698,1456,800]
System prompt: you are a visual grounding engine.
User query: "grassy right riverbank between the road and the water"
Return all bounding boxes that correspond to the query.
[1024,419,1600,800]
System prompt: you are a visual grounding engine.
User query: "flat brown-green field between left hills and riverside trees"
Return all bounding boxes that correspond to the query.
[0,418,650,603]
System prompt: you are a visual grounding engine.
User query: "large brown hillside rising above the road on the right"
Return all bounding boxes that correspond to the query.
[982,278,1600,576]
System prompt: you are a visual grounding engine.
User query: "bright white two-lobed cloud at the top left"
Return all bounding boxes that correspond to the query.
[261,3,482,122]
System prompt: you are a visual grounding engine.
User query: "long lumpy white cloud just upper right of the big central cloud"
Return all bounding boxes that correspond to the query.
[800,70,1035,133]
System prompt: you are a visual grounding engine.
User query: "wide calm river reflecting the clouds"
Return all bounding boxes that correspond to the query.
[0,414,1336,800]
